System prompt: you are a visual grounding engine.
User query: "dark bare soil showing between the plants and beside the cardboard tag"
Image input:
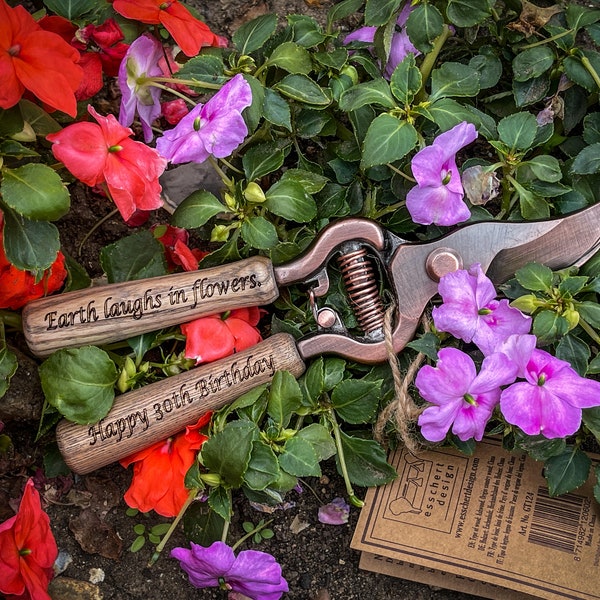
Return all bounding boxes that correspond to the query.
[0,0,592,600]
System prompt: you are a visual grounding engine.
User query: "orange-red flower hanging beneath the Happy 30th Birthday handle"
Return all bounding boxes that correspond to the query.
[121,413,211,517]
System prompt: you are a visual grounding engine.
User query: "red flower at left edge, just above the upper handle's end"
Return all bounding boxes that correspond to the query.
[0,213,67,310]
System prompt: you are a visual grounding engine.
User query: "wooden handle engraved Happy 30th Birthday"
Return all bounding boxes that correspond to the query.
[56,333,305,475]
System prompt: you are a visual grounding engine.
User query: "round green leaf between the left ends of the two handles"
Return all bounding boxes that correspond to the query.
[39,346,119,424]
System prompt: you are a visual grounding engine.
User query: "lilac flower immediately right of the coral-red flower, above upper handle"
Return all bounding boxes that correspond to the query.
[156,74,252,163]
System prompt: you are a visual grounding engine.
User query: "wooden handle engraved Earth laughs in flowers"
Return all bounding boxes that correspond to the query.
[23,256,279,356]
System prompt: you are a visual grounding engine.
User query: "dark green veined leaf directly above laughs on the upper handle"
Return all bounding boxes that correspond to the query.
[100,231,167,283]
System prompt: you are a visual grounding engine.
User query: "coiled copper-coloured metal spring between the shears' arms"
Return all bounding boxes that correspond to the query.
[337,248,385,333]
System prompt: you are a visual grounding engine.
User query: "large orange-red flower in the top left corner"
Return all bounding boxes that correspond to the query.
[0,0,83,117]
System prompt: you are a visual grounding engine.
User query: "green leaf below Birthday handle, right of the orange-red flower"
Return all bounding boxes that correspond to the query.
[201,421,258,488]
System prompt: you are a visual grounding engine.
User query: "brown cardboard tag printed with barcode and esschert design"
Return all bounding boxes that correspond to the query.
[352,438,600,600]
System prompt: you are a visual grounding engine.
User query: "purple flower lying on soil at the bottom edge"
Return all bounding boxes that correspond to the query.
[171,542,288,600]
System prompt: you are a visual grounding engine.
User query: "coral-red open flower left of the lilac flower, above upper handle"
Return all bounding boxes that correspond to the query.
[47,106,167,222]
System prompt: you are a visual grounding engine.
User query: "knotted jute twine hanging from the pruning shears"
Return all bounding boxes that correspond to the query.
[374,304,429,454]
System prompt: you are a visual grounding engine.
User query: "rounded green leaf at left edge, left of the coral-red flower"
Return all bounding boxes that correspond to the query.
[0,163,70,221]
